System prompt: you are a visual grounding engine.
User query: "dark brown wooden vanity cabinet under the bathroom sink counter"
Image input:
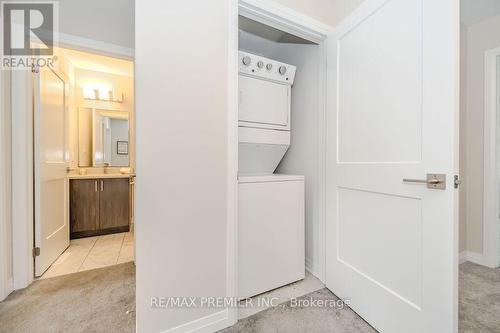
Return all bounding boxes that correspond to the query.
[70,178,130,239]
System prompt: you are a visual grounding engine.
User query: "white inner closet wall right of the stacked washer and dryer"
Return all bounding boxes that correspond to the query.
[277,45,324,278]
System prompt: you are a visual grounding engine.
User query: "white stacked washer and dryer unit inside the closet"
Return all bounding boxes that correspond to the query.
[238,52,305,297]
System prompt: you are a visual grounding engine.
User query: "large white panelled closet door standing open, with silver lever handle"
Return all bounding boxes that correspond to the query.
[326,0,459,333]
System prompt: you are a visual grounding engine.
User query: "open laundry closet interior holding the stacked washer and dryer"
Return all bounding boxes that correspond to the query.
[238,16,324,297]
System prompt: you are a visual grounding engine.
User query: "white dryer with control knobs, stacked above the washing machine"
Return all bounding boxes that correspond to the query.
[238,52,296,174]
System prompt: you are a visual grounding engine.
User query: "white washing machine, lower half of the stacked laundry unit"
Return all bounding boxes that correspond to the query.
[238,174,305,297]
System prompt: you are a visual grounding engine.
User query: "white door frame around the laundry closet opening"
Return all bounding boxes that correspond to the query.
[226,0,333,325]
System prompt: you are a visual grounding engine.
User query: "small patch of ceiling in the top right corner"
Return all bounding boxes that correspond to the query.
[460,0,500,25]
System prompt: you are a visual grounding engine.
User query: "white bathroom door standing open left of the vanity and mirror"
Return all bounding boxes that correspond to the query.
[33,67,69,276]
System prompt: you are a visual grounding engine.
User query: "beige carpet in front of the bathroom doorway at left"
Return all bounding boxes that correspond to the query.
[0,262,135,333]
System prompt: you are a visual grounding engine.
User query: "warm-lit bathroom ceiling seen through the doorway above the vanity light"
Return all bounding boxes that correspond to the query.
[56,48,134,77]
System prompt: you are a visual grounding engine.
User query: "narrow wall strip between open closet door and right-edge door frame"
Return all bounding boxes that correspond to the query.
[461,16,500,254]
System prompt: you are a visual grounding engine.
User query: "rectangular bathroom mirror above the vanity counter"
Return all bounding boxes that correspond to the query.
[78,108,130,167]
